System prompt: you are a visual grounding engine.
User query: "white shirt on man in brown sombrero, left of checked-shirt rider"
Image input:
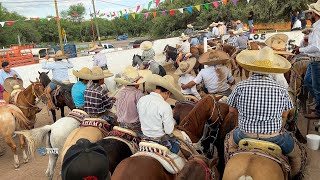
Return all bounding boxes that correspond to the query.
[193,65,234,93]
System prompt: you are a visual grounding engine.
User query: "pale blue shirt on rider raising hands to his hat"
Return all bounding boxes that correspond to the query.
[42,60,73,82]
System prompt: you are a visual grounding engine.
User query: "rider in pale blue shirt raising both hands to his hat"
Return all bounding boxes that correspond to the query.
[42,50,73,110]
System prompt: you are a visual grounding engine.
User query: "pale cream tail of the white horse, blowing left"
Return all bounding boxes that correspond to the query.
[15,125,52,157]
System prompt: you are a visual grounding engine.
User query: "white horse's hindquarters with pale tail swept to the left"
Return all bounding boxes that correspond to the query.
[15,109,88,180]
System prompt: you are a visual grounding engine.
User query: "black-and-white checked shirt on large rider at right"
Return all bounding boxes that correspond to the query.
[228,74,293,134]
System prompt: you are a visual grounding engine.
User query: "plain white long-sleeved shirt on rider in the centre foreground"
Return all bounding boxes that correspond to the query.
[137,92,176,138]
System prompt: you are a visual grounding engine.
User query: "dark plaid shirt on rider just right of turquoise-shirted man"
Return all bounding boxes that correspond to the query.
[84,84,113,114]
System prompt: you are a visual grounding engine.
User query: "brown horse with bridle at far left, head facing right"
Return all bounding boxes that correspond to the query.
[3,81,47,121]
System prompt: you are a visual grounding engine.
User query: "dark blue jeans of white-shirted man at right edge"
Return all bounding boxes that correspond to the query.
[304,61,320,116]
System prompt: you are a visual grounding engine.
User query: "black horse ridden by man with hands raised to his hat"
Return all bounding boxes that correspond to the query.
[38,71,76,122]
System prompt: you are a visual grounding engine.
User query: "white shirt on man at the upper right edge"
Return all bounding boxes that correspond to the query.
[299,20,320,57]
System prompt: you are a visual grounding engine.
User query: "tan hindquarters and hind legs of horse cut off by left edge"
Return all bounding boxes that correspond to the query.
[0,104,35,168]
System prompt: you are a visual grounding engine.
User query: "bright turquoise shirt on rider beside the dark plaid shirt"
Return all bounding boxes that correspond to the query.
[71,81,87,107]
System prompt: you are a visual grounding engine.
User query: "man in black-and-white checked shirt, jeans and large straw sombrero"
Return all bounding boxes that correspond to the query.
[226,47,302,179]
